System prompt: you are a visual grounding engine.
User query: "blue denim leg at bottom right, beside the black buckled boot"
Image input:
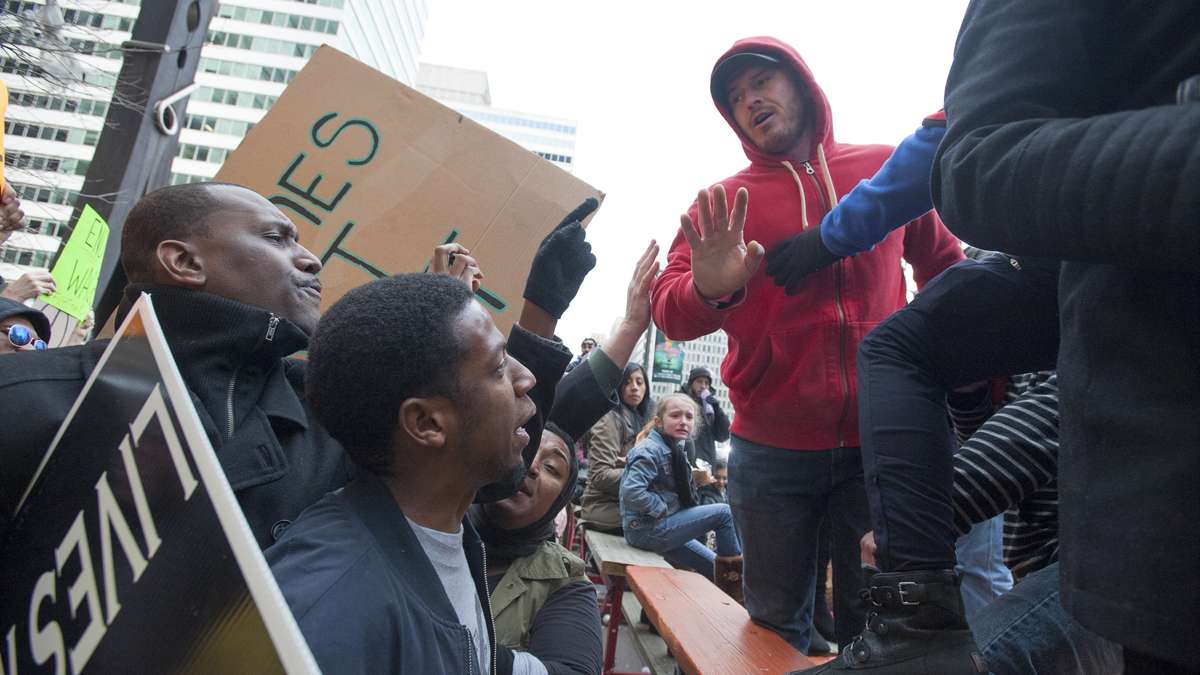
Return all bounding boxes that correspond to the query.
[971,563,1123,675]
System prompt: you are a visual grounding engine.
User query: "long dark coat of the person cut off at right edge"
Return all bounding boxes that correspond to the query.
[932,0,1200,668]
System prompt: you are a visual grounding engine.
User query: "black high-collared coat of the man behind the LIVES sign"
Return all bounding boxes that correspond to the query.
[0,287,352,548]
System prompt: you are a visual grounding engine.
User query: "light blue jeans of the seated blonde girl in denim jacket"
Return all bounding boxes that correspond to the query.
[625,504,742,579]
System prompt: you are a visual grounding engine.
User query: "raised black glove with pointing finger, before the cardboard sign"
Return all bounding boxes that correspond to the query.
[524,197,600,318]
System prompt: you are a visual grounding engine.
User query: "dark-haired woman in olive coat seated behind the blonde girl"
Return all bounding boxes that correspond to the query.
[582,363,654,531]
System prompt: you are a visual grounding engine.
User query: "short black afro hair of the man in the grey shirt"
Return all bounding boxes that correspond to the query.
[306,274,473,473]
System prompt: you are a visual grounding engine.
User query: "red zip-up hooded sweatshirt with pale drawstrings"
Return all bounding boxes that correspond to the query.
[652,37,962,450]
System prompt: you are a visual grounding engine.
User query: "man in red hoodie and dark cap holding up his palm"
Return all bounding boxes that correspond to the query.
[653,37,962,651]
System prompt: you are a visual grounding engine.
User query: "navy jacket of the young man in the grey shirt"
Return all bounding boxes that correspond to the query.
[266,471,512,675]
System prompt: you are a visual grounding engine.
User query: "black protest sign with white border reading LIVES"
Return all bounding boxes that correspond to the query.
[0,295,317,674]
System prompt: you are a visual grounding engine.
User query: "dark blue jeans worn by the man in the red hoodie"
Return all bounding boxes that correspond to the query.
[728,436,870,653]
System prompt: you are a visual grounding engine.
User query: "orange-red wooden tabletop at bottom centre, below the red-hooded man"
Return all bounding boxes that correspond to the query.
[624,566,832,675]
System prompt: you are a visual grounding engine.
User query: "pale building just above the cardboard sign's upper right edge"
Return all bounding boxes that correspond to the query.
[416,64,576,171]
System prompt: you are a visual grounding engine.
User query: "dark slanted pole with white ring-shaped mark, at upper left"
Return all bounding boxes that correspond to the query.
[68,0,217,329]
